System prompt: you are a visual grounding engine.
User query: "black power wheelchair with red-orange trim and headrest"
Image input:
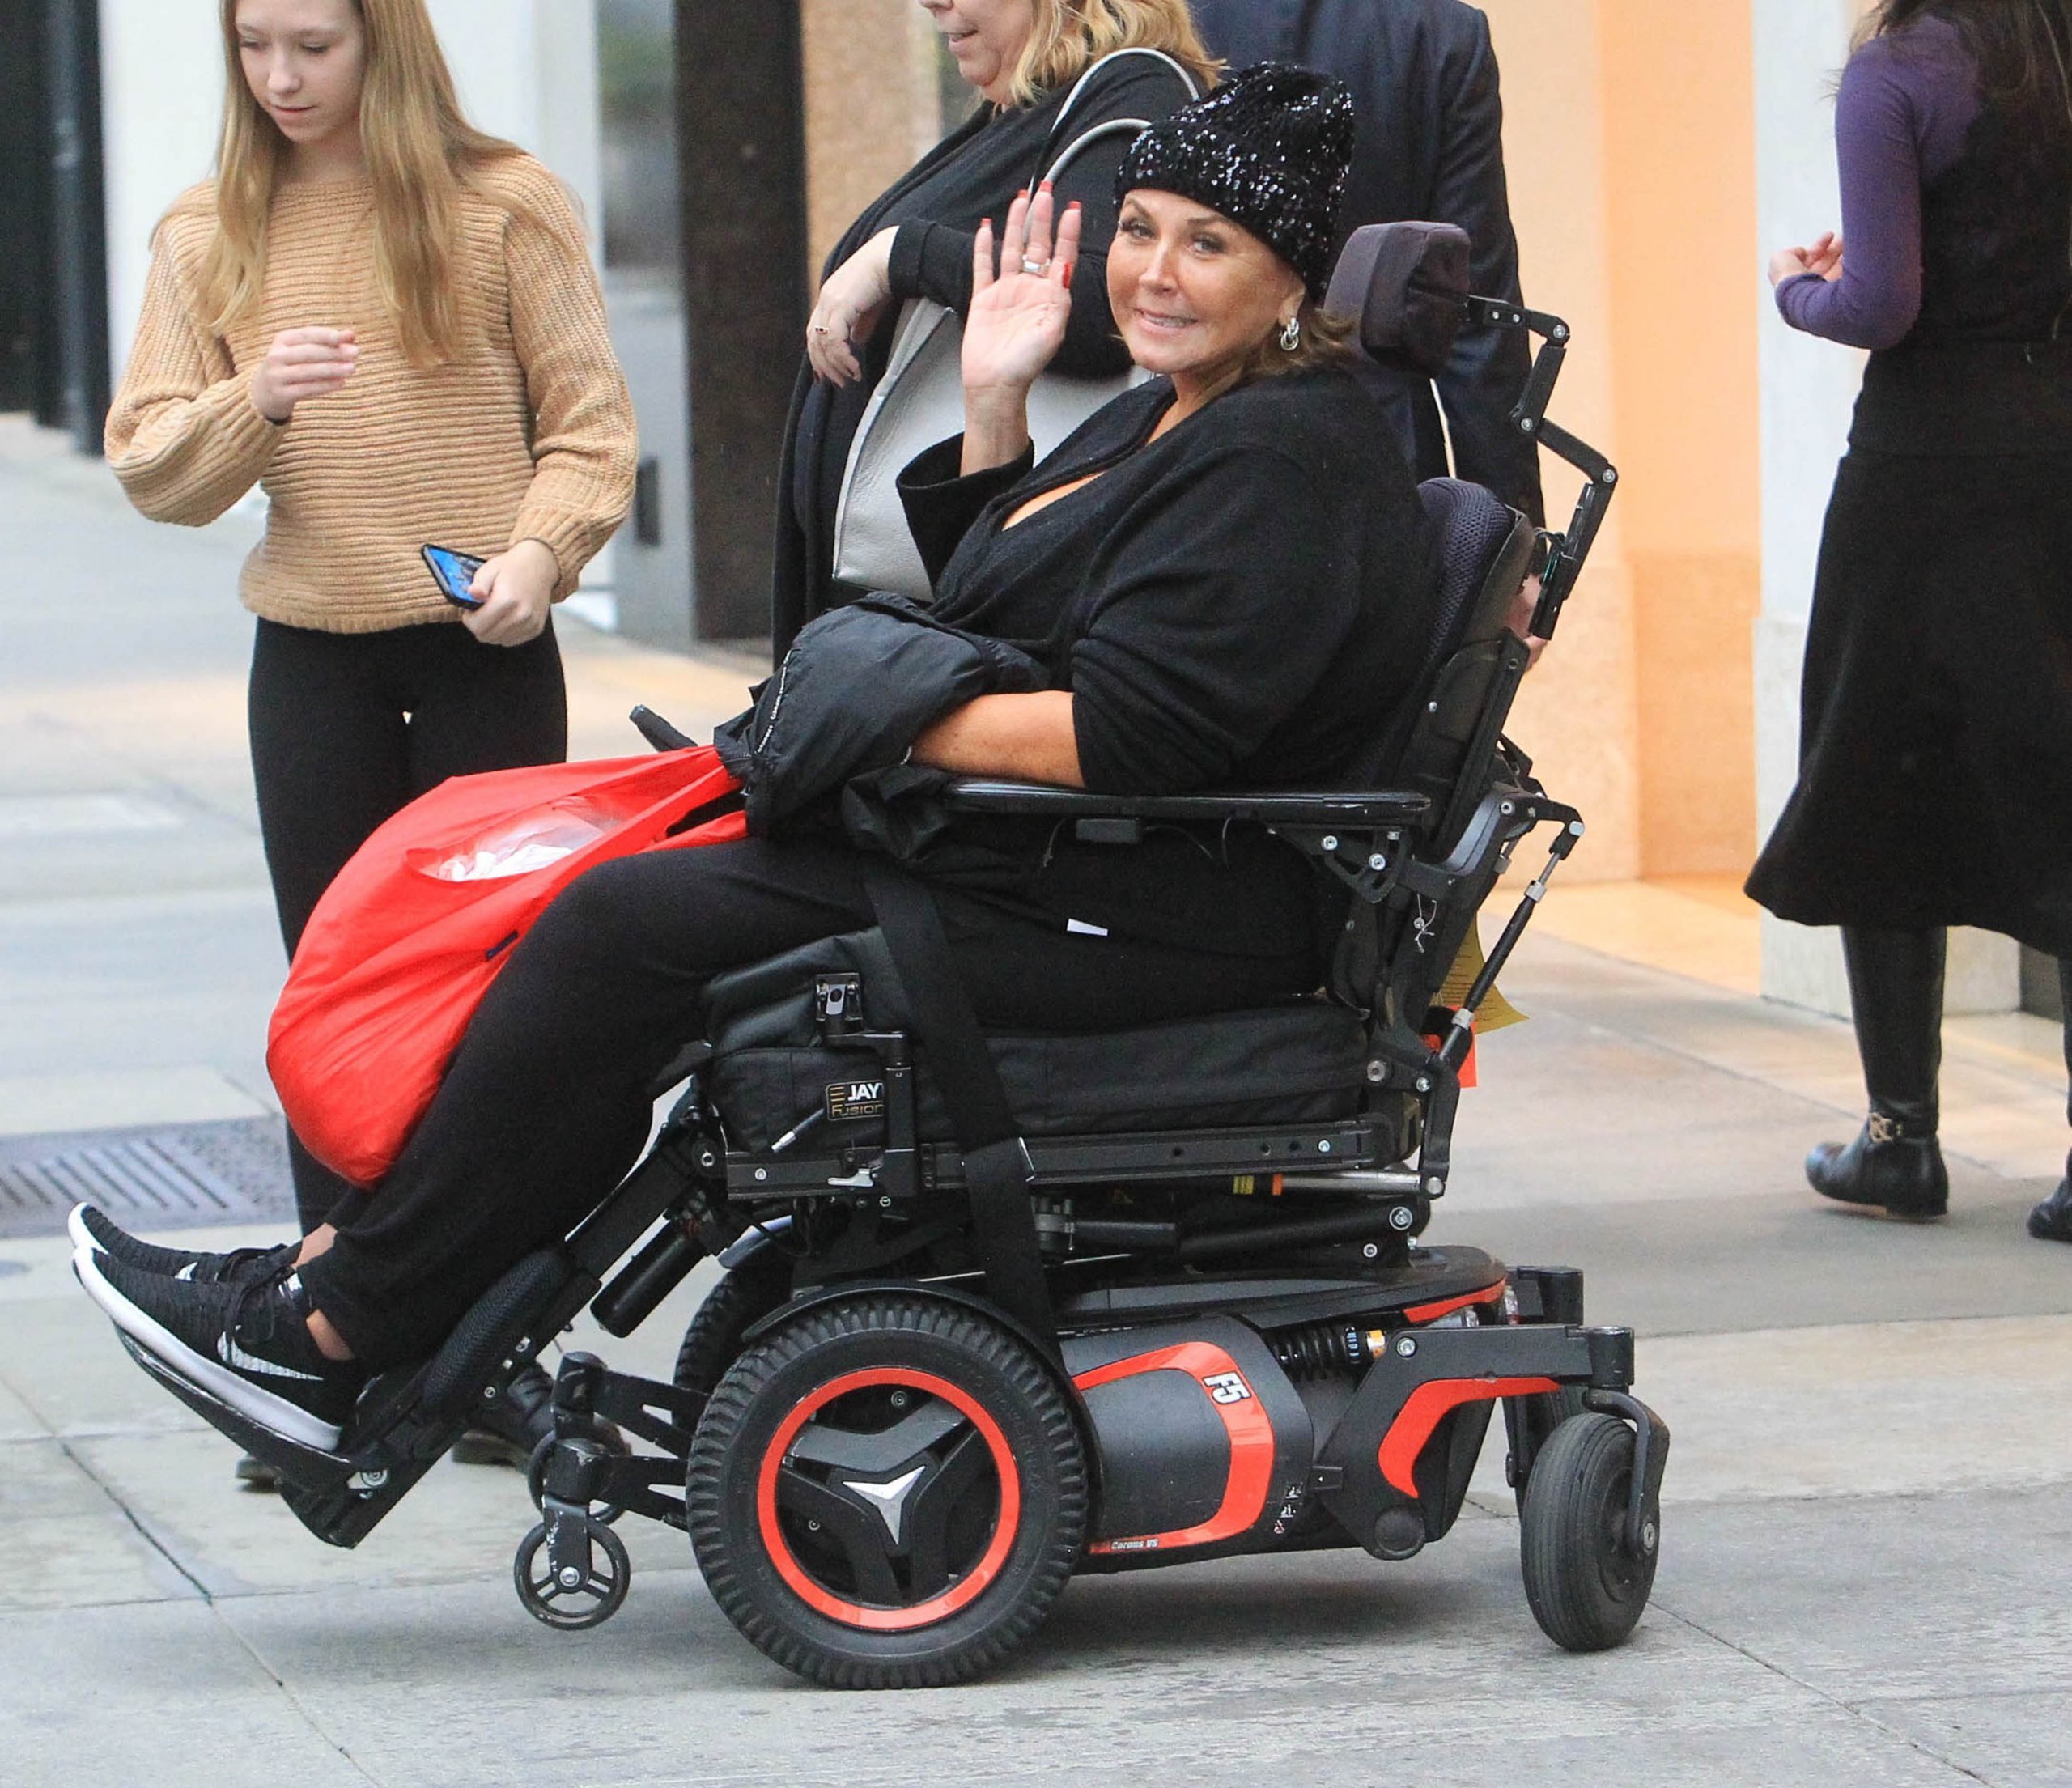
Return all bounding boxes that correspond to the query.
[126,223,1668,1687]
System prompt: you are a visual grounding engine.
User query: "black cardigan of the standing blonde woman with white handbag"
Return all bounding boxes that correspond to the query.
[771,56,1187,656]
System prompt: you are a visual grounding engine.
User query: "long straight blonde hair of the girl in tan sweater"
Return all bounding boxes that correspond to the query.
[201,0,524,367]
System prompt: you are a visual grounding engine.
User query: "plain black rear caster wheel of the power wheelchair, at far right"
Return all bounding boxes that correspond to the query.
[1518,1415,1662,1651]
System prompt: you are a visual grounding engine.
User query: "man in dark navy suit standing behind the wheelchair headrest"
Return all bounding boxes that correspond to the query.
[1191,0,1546,522]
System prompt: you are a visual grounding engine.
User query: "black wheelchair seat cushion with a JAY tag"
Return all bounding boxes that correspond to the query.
[704,930,1365,1152]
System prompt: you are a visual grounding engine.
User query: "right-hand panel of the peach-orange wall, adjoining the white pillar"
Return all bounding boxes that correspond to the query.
[1599,0,1761,877]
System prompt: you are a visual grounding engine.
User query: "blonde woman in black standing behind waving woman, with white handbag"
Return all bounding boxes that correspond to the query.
[771,0,1214,656]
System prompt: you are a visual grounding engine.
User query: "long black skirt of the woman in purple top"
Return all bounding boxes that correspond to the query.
[1749,352,2072,958]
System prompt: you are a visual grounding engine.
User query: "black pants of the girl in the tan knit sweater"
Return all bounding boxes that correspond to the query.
[248,622,567,1233]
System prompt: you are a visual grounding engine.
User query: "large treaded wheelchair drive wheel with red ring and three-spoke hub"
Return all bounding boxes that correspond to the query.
[686,1293,1088,1688]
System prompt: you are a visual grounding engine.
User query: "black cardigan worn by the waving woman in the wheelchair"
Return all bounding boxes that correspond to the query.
[902,373,1438,955]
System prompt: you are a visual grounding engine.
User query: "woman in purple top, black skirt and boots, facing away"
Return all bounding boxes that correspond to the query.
[1749,0,2072,1241]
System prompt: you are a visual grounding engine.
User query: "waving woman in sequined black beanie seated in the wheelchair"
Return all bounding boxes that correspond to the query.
[74,66,1436,1446]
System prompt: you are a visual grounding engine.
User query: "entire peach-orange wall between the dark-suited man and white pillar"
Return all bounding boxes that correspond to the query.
[1486,0,1761,878]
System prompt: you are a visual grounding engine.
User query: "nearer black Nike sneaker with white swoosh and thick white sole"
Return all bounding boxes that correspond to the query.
[73,1247,367,1452]
